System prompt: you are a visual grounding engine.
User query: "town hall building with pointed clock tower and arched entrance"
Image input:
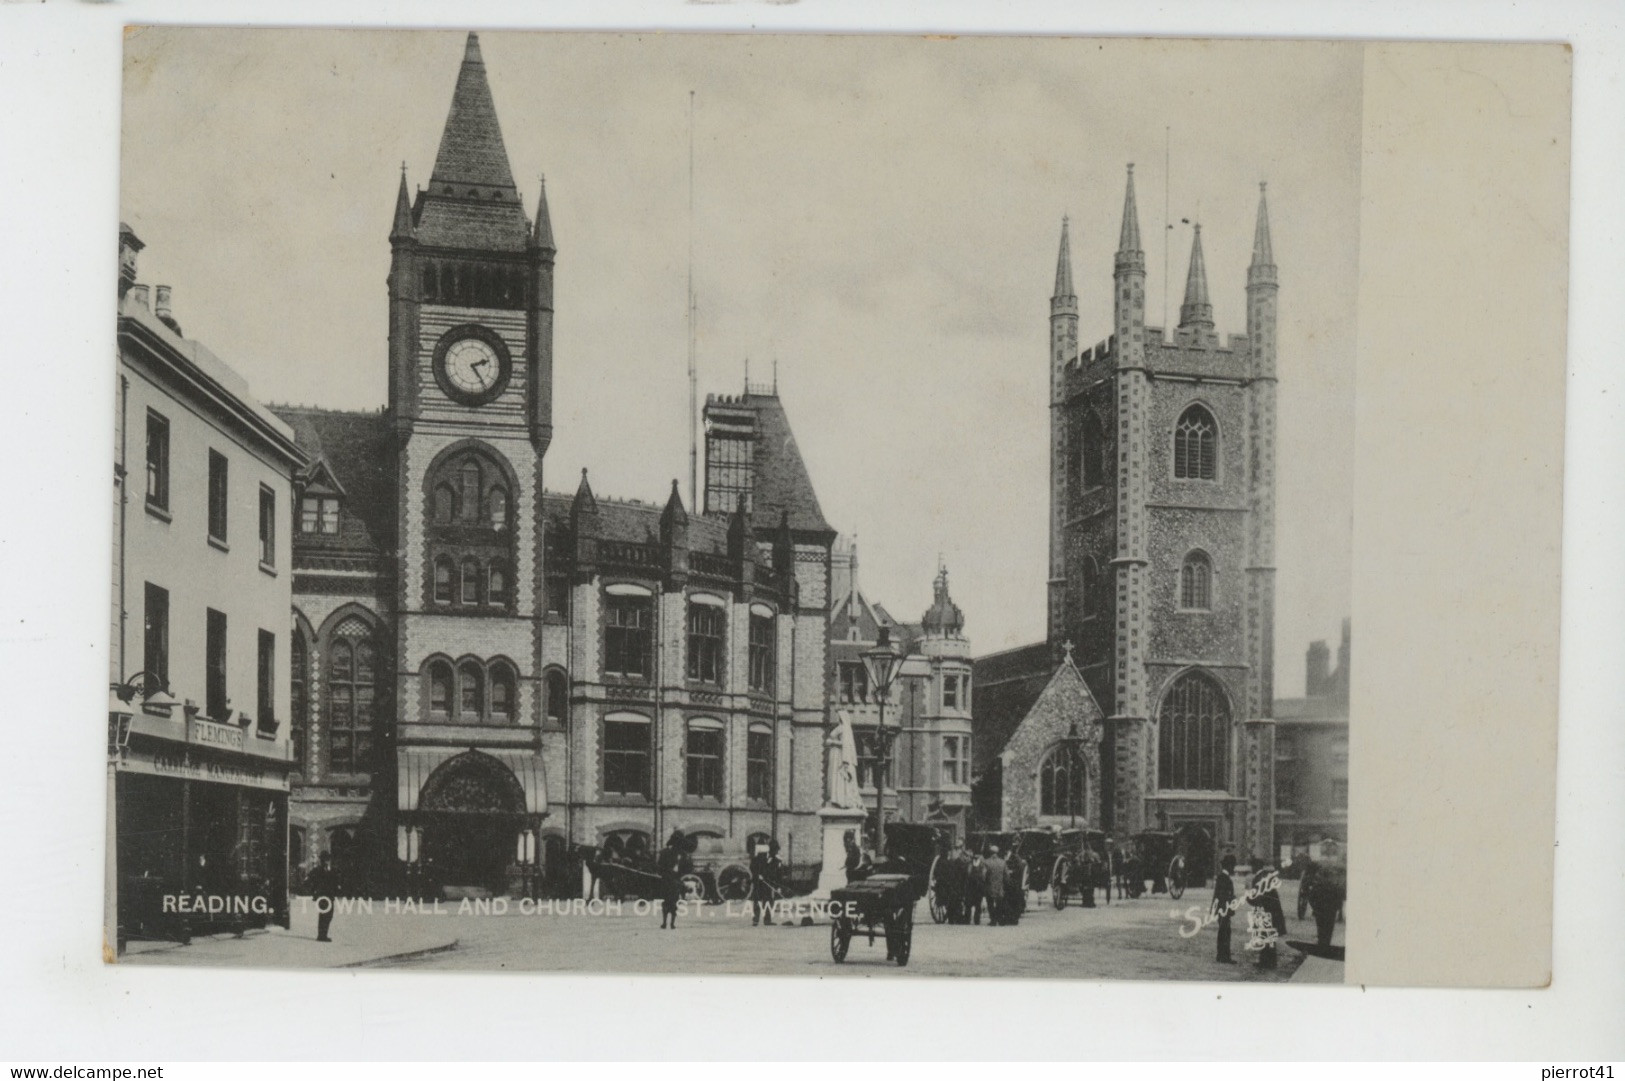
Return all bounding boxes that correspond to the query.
[278,34,835,894]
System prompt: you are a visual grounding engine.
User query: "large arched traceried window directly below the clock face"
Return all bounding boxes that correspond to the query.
[426,447,515,613]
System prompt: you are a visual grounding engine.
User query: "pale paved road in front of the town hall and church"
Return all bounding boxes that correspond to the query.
[368,884,1341,982]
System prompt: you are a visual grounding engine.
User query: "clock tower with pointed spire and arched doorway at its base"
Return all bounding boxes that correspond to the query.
[388,34,554,891]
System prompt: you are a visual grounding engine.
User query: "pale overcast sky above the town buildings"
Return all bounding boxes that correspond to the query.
[120,28,1362,696]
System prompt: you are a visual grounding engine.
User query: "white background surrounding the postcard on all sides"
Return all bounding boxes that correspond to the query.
[0,0,1625,1061]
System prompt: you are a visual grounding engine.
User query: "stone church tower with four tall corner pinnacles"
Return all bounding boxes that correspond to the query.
[1048,166,1277,857]
